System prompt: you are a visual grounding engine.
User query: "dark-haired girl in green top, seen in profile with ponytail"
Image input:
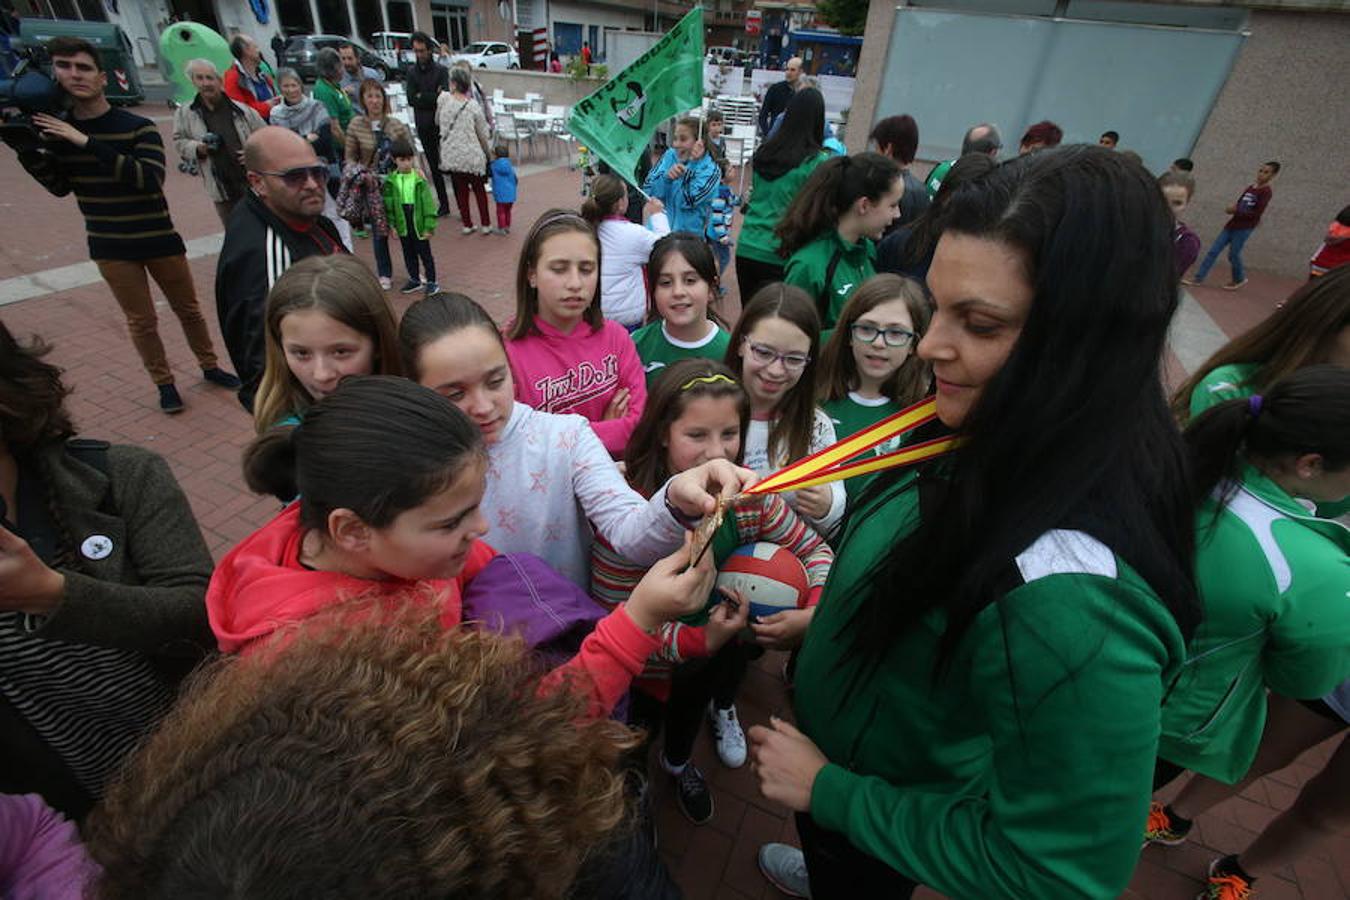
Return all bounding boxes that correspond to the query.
[774,152,905,328]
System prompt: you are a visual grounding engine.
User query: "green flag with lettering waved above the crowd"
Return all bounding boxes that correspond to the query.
[568,7,703,179]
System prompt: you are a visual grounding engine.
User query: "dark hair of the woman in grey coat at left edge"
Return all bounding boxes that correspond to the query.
[0,321,76,452]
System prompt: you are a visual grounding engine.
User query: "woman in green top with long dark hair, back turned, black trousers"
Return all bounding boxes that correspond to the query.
[736,88,830,304]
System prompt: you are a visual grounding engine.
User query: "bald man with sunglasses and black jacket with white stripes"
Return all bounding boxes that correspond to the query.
[216,125,347,412]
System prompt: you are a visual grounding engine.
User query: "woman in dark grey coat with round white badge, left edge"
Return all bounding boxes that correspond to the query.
[0,324,215,818]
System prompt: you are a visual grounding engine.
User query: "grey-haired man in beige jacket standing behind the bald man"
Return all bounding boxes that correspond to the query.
[173,59,266,225]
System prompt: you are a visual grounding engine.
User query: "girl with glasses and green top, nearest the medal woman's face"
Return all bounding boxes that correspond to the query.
[821,275,933,501]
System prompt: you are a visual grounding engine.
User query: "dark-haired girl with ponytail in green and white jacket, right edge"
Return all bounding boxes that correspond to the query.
[1145,366,1350,896]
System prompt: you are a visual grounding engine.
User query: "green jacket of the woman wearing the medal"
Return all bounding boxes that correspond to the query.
[794,475,1184,900]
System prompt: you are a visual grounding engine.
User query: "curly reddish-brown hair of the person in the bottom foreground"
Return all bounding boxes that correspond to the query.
[86,591,636,899]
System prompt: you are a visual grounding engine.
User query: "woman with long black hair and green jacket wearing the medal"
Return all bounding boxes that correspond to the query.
[751,147,1199,900]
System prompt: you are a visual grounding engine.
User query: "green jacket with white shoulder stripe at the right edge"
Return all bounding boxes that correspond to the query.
[1158,466,1350,784]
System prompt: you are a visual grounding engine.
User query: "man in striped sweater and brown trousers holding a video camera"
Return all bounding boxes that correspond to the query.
[19,38,239,413]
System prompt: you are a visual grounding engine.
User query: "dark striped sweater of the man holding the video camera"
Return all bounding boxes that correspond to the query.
[19,108,185,260]
